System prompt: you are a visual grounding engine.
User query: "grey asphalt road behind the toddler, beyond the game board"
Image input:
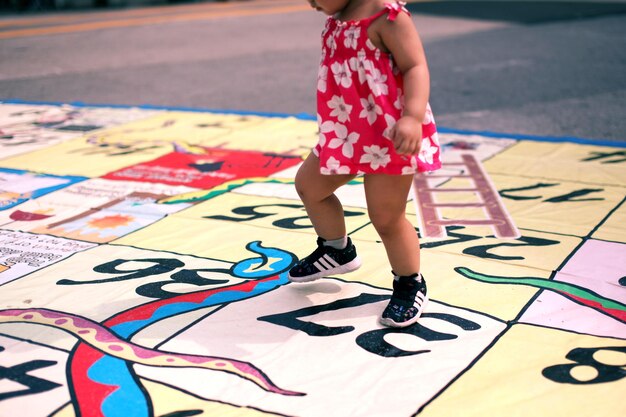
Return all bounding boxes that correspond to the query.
[0,0,626,142]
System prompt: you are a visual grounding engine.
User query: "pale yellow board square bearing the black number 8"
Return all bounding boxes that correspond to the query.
[420,324,626,417]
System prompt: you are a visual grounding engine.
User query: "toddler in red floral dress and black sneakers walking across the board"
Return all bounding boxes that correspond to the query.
[289,0,441,327]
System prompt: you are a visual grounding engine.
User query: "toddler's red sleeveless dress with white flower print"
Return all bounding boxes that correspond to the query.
[313,3,441,175]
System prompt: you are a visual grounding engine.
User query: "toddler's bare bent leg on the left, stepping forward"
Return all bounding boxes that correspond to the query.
[296,154,355,240]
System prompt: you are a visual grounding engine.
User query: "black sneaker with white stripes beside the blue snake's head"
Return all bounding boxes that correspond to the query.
[289,237,361,282]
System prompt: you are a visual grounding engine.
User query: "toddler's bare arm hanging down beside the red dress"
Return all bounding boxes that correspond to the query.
[378,13,430,155]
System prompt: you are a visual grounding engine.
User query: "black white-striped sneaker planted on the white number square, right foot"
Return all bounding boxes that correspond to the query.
[380,275,428,327]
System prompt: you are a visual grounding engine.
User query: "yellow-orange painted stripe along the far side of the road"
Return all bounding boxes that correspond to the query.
[0,1,310,39]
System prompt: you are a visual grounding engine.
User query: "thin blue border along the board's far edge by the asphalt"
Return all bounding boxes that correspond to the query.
[0,99,626,148]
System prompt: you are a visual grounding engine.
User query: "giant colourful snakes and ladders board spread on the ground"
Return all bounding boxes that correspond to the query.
[0,103,626,417]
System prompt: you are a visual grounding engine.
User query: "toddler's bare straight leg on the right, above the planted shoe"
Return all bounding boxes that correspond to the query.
[365,175,420,276]
